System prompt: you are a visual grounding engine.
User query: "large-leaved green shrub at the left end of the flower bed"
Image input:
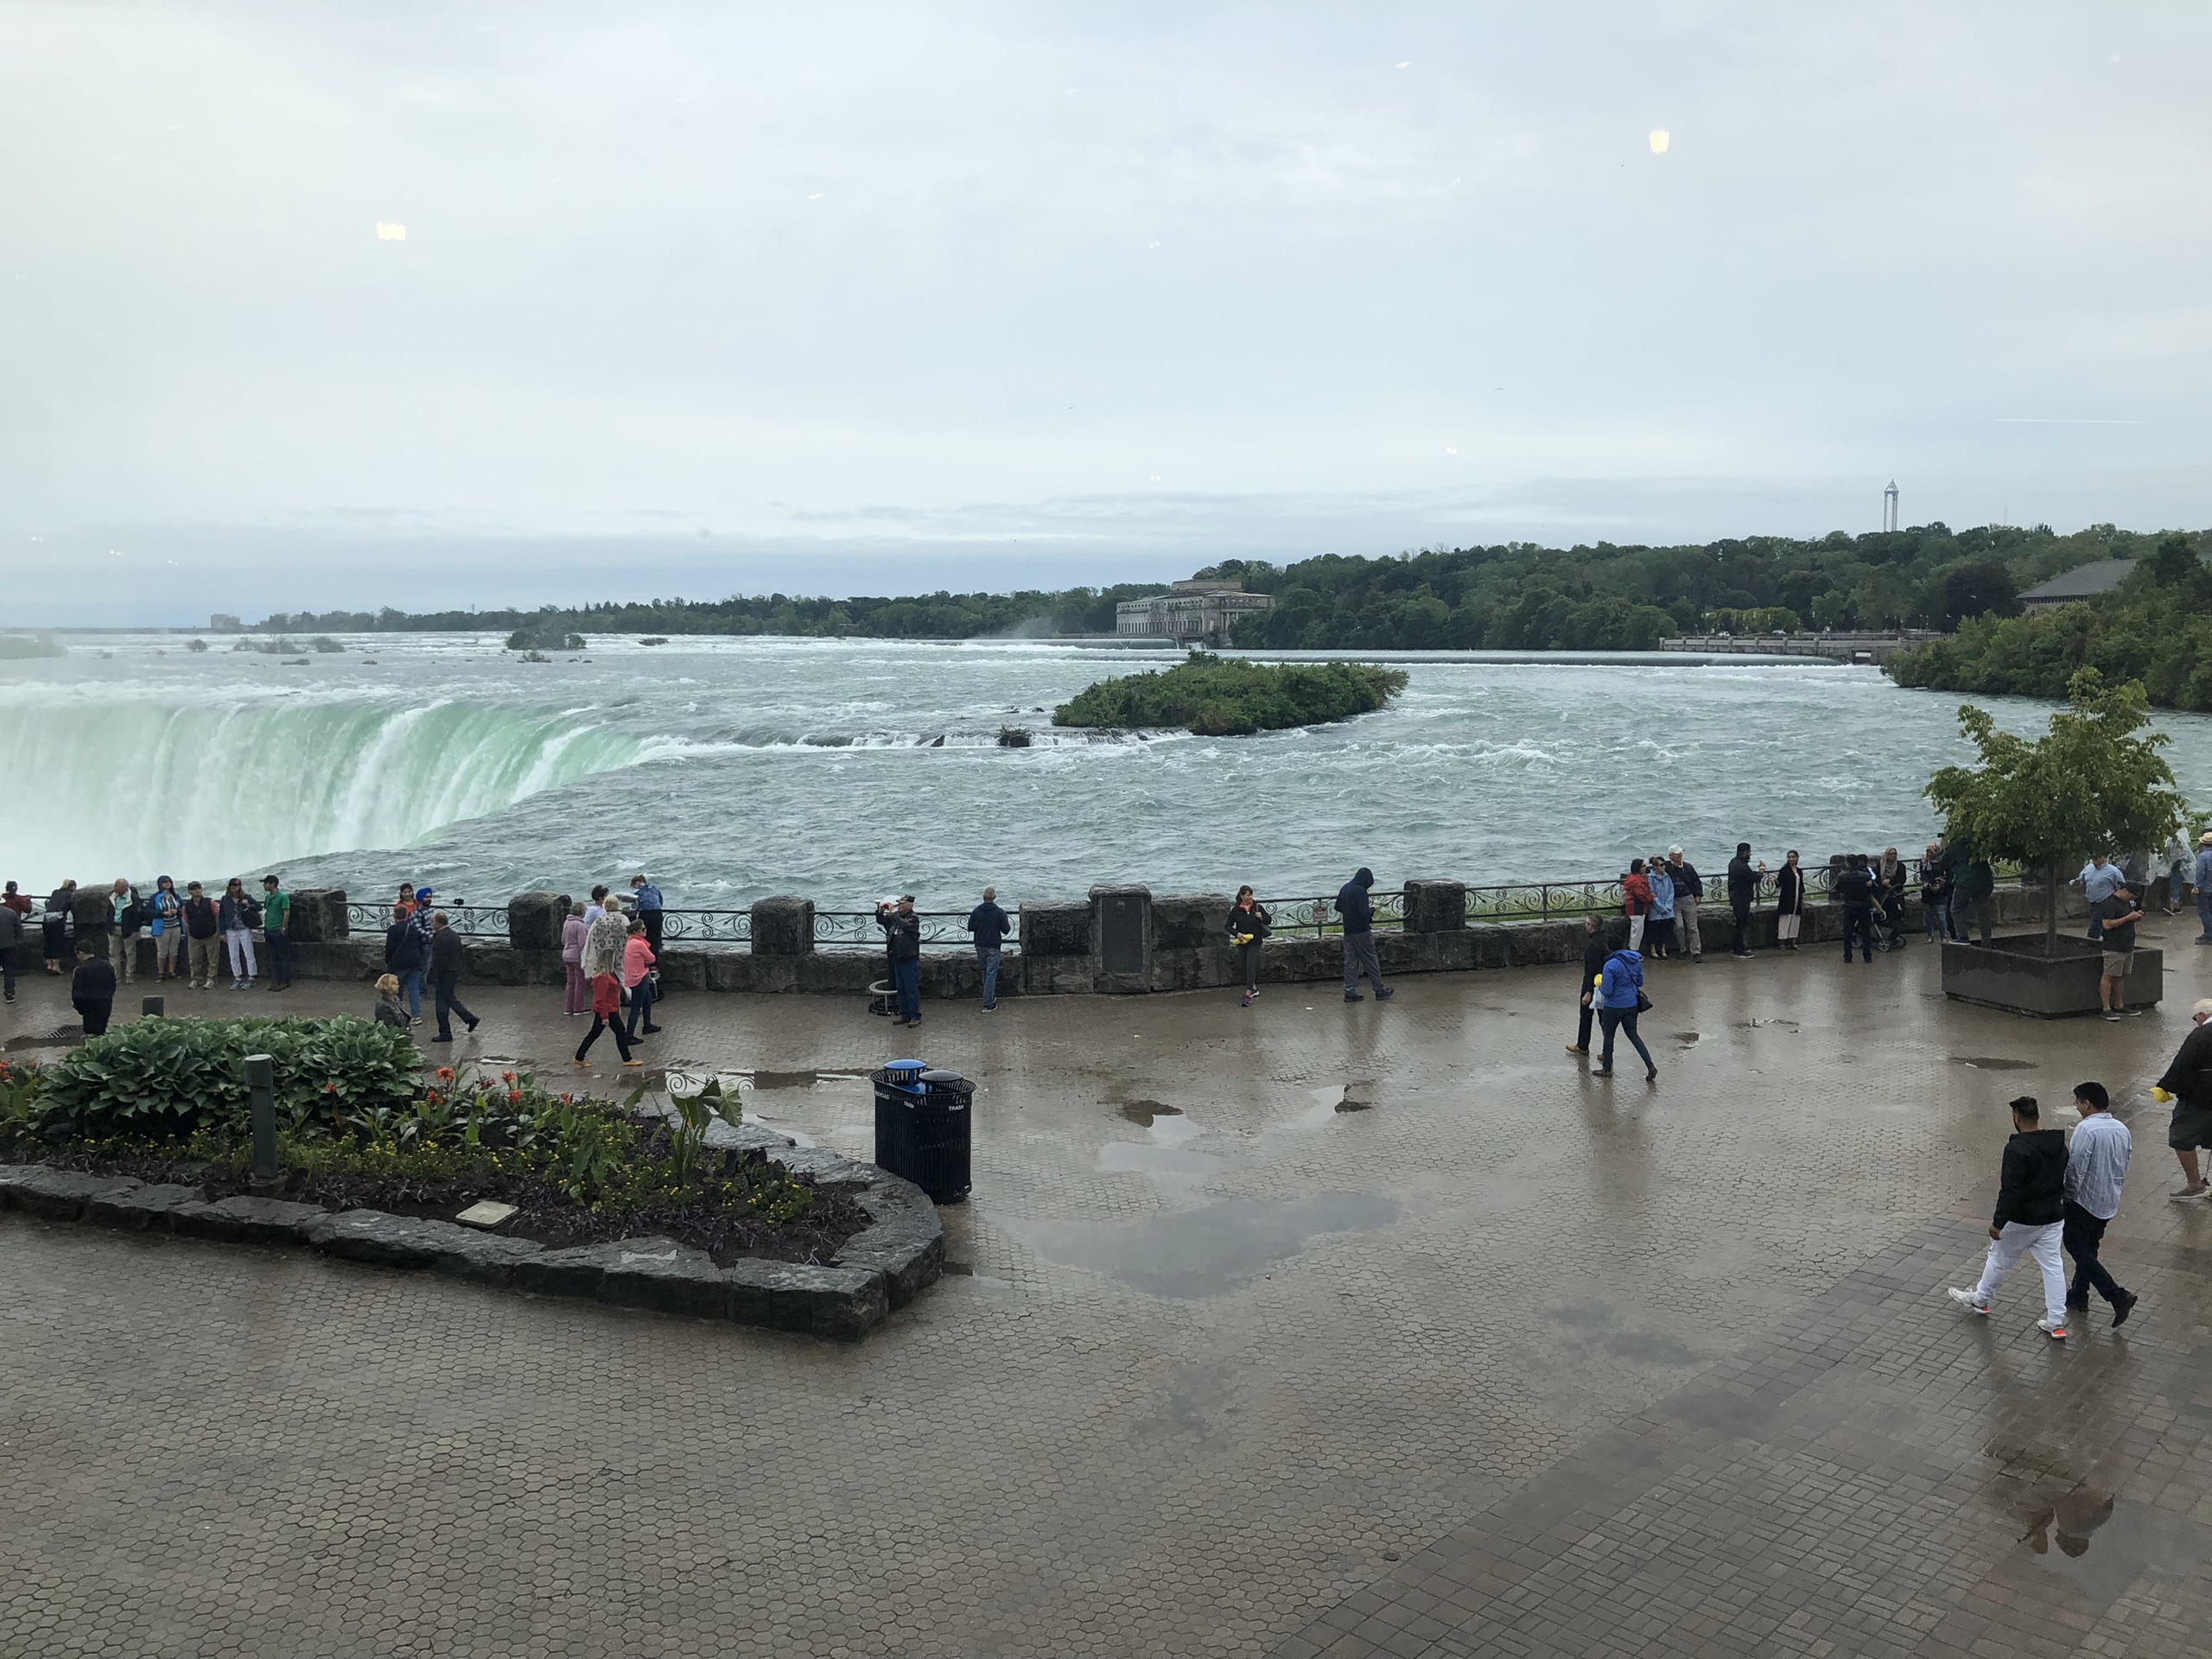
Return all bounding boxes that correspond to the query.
[38,1018,423,1139]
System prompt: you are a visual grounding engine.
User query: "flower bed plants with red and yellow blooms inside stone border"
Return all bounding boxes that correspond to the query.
[0,1020,869,1265]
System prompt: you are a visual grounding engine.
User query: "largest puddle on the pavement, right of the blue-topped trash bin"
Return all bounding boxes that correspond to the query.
[993,1192,1398,1300]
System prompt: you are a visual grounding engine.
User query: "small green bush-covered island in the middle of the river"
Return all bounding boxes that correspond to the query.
[1053,651,1405,736]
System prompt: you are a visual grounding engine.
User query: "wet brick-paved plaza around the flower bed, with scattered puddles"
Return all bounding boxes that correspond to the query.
[0,927,2212,1659]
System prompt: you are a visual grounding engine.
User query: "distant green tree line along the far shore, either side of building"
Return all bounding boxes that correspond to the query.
[257,524,2201,658]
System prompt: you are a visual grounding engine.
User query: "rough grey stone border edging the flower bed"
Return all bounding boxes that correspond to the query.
[0,1123,944,1343]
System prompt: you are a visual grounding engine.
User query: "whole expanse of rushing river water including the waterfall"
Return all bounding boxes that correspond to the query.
[0,635,2212,909]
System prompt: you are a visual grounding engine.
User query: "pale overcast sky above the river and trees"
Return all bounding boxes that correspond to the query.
[0,0,2212,624]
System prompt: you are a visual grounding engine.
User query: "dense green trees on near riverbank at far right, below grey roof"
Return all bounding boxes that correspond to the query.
[1889,536,2212,708]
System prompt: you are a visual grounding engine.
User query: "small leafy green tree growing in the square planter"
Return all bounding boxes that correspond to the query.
[1927,668,2188,957]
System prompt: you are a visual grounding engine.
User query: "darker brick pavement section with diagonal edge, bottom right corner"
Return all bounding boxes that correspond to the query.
[1276,1224,2212,1659]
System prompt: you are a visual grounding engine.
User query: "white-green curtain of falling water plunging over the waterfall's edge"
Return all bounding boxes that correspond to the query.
[0,696,641,892]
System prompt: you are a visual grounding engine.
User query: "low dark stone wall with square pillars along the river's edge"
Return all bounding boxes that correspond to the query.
[79,880,2052,998]
